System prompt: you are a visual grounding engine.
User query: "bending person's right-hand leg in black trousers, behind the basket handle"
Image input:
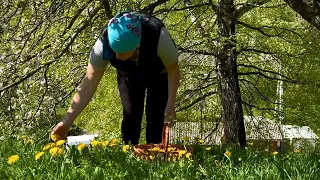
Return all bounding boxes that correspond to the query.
[146,73,168,144]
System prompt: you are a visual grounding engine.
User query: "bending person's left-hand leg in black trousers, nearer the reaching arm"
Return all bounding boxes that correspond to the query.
[117,71,146,145]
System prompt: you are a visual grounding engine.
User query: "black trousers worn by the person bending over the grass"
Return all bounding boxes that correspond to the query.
[117,71,168,145]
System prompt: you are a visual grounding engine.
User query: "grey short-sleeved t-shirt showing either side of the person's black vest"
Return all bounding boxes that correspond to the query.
[90,27,178,67]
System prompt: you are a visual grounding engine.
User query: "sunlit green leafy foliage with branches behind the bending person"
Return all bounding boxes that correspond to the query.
[0,0,320,140]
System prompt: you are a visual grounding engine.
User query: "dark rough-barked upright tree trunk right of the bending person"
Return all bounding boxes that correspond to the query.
[217,0,246,147]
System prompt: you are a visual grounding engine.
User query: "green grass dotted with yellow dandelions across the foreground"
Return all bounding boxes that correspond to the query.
[0,137,320,180]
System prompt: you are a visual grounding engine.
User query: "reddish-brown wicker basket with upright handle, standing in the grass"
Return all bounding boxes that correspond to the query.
[133,123,192,160]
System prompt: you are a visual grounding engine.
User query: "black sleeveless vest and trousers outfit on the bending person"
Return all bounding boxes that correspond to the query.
[102,14,168,144]
